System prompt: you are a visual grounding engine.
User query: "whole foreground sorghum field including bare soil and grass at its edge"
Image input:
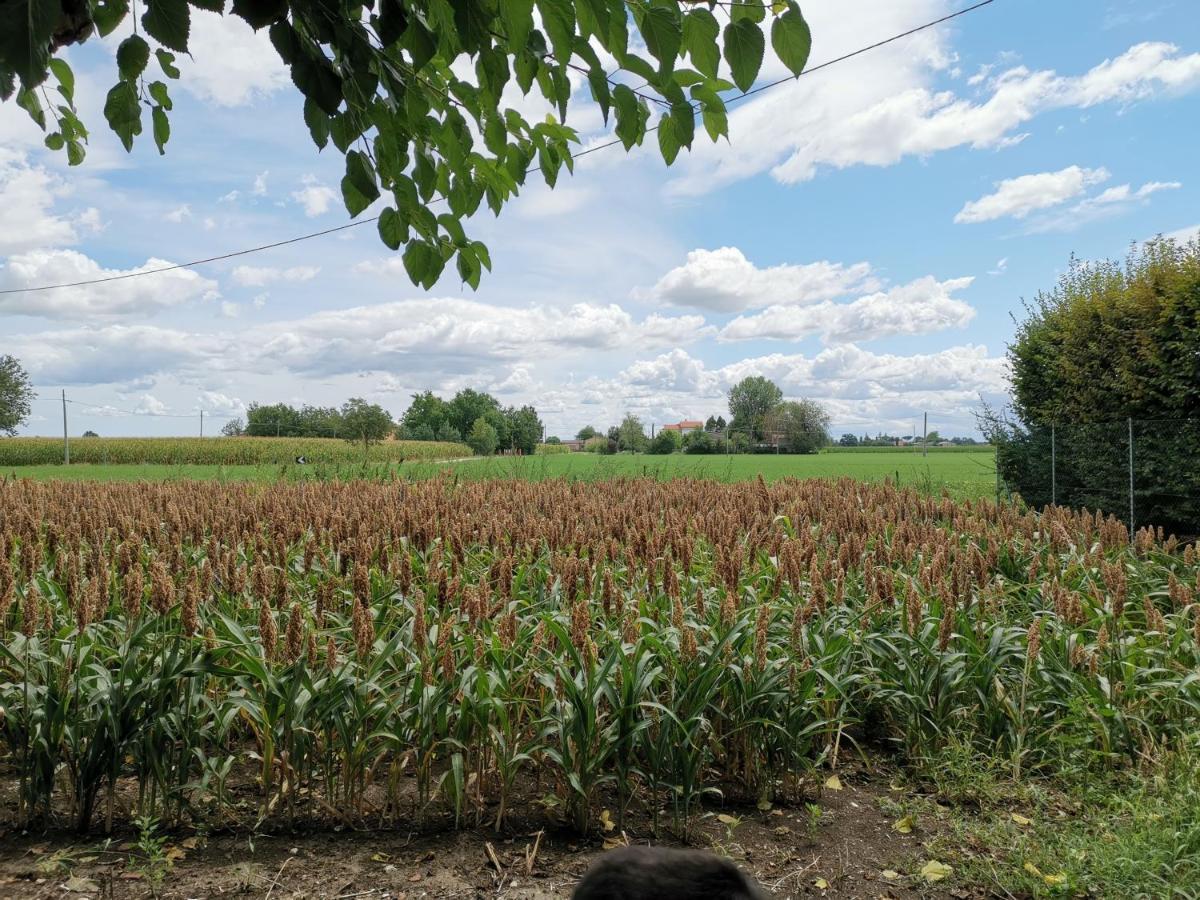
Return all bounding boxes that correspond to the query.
[0,475,1200,898]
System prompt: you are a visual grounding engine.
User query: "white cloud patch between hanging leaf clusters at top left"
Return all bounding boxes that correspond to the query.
[176,10,292,107]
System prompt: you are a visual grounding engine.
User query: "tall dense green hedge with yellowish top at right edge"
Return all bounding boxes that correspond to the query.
[991,239,1200,535]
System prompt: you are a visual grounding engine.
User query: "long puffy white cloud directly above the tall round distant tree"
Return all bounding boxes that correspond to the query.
[719,276,974,343]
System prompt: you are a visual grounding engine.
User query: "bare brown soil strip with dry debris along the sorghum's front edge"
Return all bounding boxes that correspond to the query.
[0,773,960,900]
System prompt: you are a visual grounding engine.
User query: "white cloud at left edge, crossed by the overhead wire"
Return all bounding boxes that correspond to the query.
[0,250,217,319]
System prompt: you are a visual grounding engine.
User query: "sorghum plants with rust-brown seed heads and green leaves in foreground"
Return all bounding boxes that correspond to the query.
[0,479,1200,832]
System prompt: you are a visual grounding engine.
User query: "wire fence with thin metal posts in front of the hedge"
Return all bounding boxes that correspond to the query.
[996,419,1200,536]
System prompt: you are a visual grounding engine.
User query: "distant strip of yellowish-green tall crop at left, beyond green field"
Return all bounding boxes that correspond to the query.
[0,437,472,467]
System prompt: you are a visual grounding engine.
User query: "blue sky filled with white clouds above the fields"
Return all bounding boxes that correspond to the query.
[0,0,1200,436]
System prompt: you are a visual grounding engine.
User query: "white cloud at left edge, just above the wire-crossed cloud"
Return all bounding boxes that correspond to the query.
[0,148,91,256]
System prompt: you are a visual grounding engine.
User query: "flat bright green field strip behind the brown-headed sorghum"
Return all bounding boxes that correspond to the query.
[0,449,996,497]
